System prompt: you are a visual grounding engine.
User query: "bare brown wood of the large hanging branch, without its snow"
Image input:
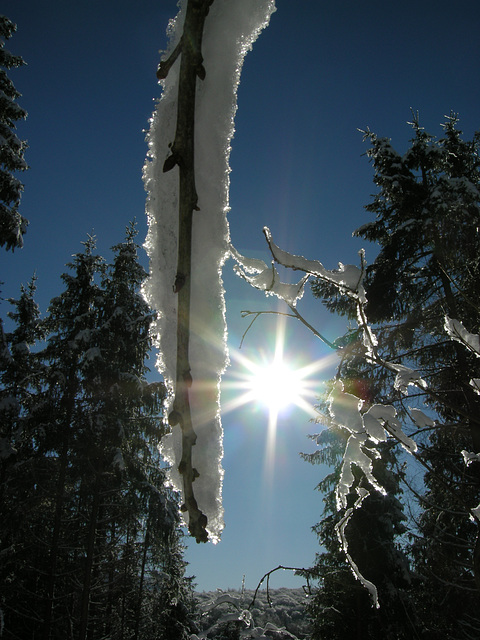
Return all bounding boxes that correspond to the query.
[161,0,213,542]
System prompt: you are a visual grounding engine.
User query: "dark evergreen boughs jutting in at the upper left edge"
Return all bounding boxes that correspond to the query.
[0,15,28,251]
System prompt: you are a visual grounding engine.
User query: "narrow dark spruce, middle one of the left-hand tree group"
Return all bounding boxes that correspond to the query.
[37,238,104,638]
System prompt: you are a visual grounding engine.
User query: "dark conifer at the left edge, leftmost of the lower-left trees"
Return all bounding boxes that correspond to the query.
[0,278,43,631]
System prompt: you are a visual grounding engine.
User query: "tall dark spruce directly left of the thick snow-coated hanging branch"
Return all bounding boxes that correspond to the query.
[75,224,193,639]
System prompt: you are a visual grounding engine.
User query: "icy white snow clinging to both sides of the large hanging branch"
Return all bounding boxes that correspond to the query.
[144,0,275,542]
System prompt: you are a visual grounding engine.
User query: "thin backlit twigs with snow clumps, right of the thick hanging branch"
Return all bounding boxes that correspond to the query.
[231,228,480,606]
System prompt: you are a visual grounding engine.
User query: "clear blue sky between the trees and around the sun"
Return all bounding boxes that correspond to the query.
[0,0,480,590]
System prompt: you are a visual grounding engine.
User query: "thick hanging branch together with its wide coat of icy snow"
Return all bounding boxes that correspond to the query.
[144,0,275,542]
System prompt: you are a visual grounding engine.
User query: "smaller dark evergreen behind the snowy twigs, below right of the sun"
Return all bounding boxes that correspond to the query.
[302,361,415,640]
